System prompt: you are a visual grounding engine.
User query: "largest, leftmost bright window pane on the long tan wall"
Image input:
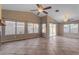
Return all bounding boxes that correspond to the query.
[5,21,15,35]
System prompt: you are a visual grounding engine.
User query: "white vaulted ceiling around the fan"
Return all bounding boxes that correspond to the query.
[2,4,79,22]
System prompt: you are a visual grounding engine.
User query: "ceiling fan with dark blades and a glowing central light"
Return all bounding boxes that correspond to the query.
[31,4,52,15]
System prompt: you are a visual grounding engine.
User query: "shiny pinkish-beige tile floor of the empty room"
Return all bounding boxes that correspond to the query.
[0,37,79,55]
